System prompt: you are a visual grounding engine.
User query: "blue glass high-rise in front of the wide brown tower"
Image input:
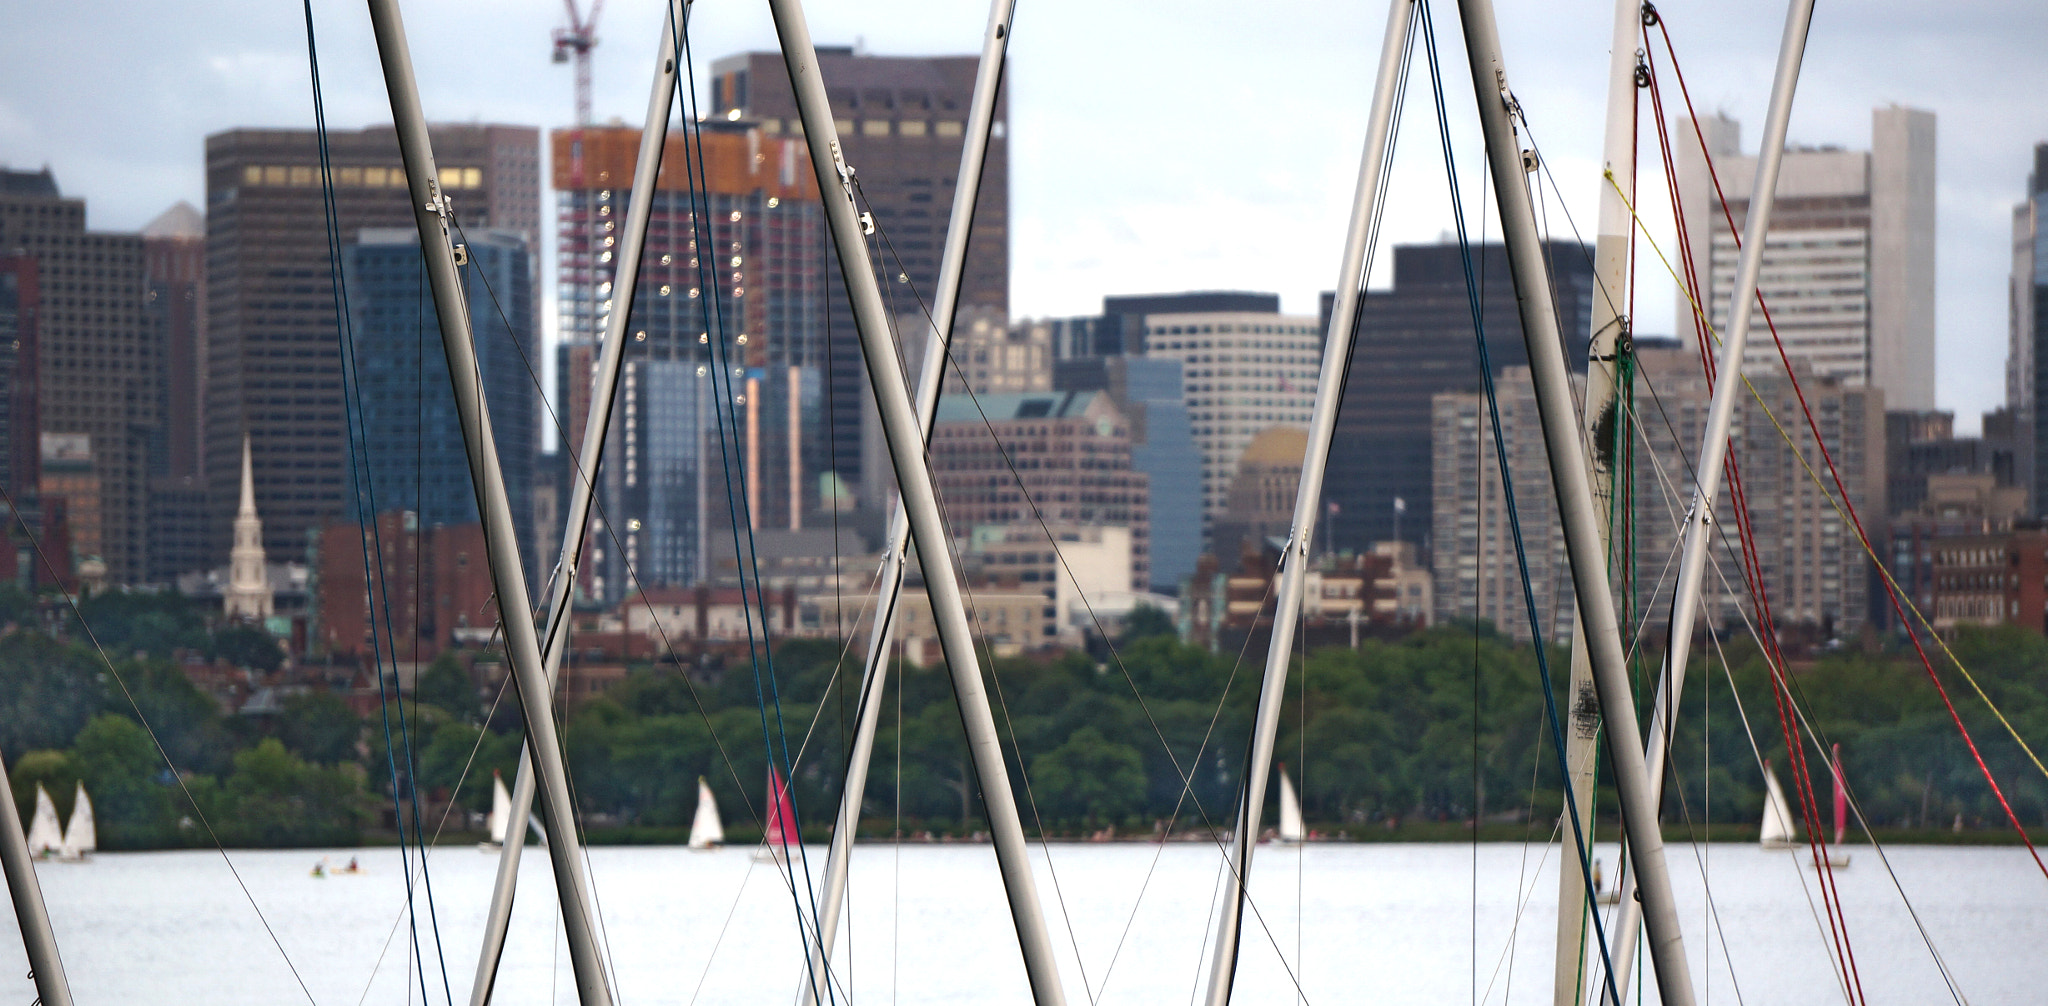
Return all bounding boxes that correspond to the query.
[344,227,536,584]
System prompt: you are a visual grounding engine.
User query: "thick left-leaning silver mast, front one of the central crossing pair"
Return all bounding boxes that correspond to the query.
[768,0,1065,1006]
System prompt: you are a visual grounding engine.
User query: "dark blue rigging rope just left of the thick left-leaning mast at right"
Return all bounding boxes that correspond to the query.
[1417,0,1620,1006]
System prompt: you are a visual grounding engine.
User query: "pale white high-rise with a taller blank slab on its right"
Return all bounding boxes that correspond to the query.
[1675,104,1935,410]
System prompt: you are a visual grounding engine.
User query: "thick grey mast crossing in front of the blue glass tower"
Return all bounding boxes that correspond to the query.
[369,0,612,1006]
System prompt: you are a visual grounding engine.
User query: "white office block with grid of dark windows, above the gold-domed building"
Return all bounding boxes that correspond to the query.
[1145,311,1323,537]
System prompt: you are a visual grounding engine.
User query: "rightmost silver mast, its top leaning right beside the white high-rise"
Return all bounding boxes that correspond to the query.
[1614,0,1812,990]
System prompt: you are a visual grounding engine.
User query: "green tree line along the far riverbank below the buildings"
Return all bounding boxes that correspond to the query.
[0,594,2048,848]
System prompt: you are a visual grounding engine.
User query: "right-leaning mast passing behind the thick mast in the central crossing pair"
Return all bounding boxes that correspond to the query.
[805,0,1016,1006]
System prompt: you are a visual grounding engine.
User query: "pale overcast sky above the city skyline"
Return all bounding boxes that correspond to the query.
[0,0,2048,430]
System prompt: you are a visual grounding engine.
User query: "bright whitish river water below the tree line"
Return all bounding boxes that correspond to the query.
[0,844,2048,1006]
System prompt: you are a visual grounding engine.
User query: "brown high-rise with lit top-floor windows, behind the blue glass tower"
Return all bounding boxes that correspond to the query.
[201,125,541,561]
